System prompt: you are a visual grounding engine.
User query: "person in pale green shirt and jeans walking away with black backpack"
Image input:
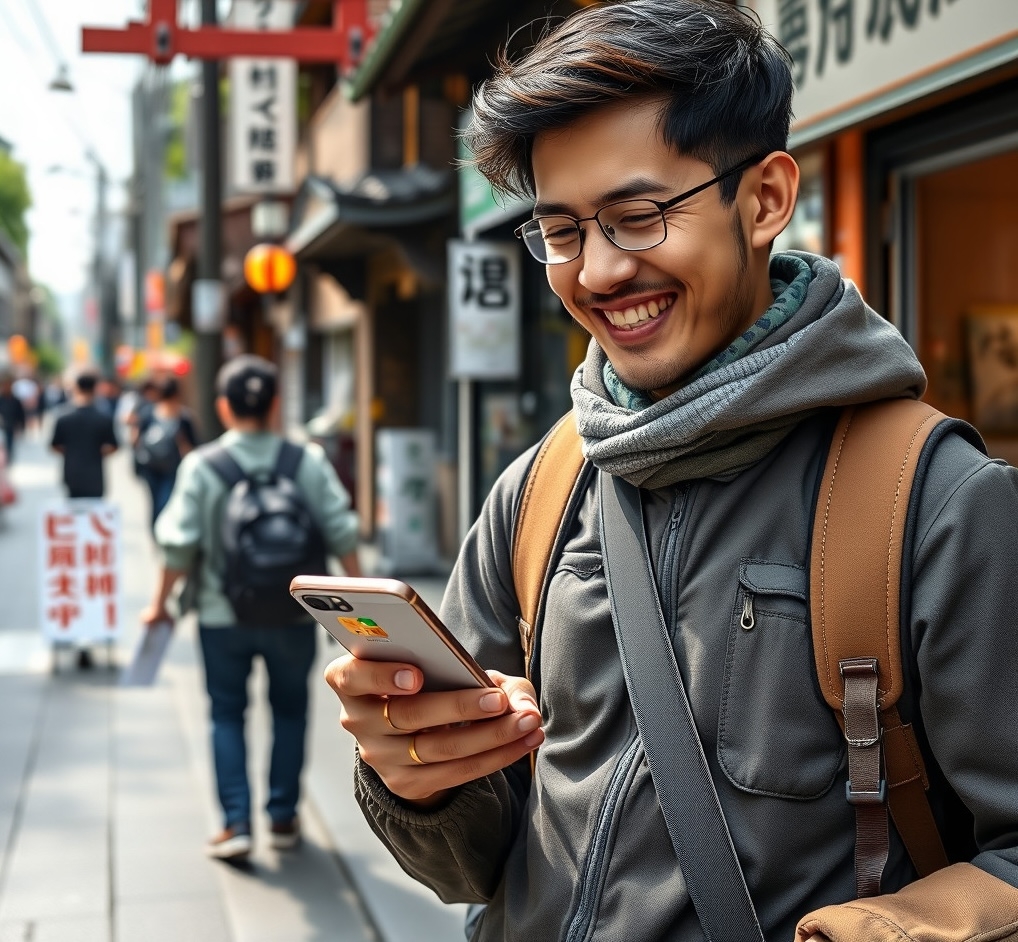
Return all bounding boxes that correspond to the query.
[142,354,360,860]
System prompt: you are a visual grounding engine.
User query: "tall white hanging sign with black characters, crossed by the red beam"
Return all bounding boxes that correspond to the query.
[229,0,297,193]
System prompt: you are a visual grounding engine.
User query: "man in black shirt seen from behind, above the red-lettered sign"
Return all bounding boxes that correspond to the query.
[50,373,117,497]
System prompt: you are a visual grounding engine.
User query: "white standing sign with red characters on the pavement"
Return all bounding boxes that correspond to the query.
[39,500,121,643]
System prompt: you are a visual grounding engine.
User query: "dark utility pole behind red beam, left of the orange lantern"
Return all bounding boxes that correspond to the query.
[191,0,224,438]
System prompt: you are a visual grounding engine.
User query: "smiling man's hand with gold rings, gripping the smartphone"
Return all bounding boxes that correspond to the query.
[325,655,545,808]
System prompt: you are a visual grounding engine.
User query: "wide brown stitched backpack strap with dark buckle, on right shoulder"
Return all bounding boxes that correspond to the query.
[809,399,948,896]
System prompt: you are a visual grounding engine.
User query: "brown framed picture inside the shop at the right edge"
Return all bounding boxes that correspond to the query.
[966,304,1018,435]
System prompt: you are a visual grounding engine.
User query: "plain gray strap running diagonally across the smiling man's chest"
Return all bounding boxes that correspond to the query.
[599,473,764,942]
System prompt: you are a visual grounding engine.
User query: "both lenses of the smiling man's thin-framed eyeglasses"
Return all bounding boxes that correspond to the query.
[523,200,665,265]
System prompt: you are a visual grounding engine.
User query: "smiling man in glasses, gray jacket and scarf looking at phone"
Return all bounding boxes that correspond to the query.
[328,0,1018,942]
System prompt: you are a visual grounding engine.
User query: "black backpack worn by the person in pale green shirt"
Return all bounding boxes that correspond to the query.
[202,439,328,625]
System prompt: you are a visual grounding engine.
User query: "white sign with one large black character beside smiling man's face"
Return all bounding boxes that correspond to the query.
[449,239,520,380]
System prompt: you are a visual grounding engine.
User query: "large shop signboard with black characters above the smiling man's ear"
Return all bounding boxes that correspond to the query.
[743,0,1018,142]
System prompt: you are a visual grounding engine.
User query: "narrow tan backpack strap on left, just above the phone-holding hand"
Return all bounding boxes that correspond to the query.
[512,412,583,677]
